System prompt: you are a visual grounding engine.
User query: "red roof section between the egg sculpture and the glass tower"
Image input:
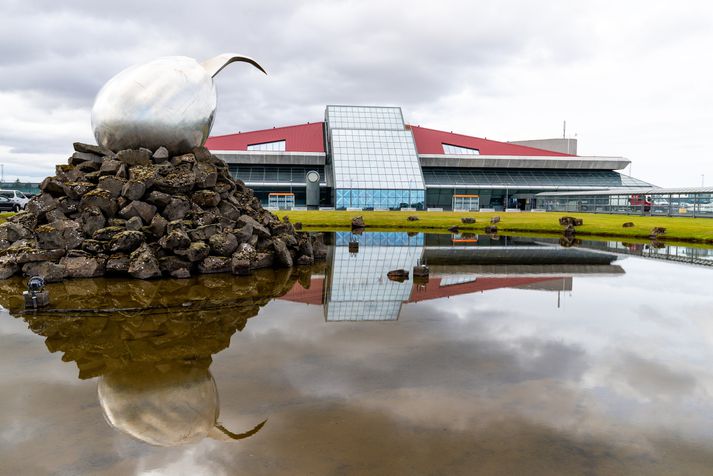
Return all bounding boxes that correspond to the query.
[200,122,324,152]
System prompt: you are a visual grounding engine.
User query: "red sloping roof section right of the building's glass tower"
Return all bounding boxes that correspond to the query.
[409,126,573,157]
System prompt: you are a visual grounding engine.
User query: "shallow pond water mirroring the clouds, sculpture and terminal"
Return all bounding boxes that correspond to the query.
[0,233,713,474]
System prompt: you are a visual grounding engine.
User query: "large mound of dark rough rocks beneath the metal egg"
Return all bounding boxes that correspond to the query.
[0,143,326,282]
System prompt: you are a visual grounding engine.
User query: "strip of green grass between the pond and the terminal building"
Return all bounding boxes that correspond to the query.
[277,210,713,243]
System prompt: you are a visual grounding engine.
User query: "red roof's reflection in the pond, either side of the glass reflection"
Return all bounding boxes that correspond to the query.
[279,276,562,304]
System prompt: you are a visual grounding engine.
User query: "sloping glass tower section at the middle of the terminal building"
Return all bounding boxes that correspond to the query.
[325,106,426,209]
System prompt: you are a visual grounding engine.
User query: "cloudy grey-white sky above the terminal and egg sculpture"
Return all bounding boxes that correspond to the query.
[0,0,713,186]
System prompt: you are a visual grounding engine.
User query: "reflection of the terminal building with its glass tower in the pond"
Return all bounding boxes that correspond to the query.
[280,232,624,321]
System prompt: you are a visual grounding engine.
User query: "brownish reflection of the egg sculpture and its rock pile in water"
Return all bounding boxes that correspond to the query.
[0,268,318,446]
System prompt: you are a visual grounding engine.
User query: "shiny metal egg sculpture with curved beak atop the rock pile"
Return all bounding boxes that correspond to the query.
[92,53,265,155]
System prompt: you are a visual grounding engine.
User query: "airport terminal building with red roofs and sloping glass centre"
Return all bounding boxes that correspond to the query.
[206,106,652,210]
